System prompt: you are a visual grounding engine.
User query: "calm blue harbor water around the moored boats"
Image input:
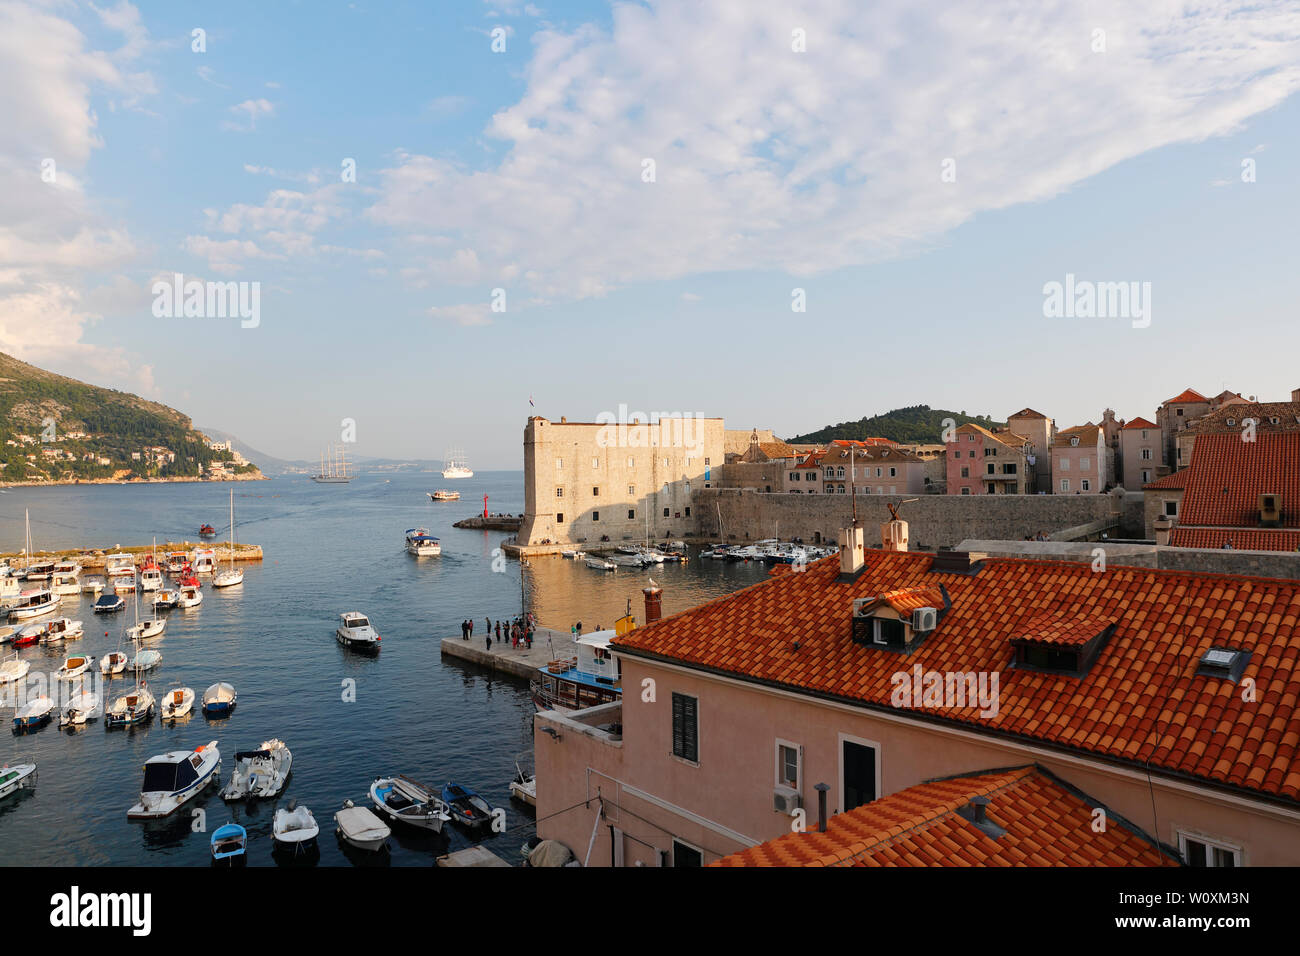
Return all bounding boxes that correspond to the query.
[0,472,763,865]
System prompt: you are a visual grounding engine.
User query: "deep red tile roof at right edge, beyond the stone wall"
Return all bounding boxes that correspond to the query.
[1178,432,1300,528]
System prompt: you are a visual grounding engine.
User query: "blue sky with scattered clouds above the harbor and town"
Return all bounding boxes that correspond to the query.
[0,0,1300,468]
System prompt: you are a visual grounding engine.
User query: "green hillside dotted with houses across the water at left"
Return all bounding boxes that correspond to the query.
[0,352,260,481]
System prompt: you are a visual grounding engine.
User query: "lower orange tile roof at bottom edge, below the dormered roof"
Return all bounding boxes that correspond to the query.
[710,767,1178,866]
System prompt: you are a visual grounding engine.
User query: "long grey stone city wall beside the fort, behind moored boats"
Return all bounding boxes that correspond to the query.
[694,488,1141,550]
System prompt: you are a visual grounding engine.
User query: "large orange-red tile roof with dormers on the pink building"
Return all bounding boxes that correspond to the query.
[615,550,1300,804]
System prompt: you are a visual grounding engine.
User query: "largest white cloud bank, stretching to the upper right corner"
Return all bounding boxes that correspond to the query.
[368,0,1300,299]
